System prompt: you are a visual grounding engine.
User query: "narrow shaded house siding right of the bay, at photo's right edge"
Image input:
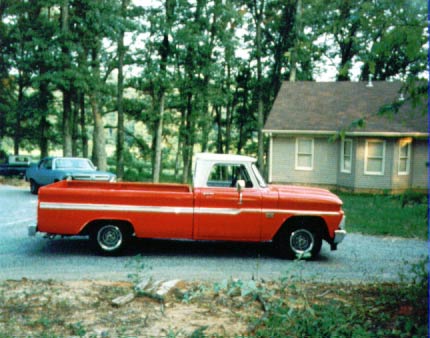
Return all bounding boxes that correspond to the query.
[411,140,429,189]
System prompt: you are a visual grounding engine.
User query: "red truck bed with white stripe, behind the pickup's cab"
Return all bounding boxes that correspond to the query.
[38,181,194,238]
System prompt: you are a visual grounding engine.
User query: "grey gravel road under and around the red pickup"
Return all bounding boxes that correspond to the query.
[0,185,428,283]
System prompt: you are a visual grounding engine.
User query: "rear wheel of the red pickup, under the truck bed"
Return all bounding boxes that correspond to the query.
[90,222,131,255]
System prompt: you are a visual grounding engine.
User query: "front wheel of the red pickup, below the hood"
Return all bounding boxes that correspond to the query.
[276,226,322,259]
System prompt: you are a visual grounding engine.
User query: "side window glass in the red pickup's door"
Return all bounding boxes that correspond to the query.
[207,164,253,188]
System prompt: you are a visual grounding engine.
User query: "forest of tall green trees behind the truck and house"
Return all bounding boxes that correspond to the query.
[0,0,428,182]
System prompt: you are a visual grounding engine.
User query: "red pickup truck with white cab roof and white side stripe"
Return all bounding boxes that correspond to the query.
[29,154,346,258]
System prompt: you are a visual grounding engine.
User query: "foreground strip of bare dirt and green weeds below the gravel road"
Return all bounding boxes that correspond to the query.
[0,279,428,338]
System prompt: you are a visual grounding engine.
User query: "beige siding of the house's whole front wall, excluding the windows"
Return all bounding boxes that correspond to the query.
[269,135,429,193]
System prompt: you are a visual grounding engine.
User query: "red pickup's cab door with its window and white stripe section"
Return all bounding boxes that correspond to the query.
[194,164,262,241]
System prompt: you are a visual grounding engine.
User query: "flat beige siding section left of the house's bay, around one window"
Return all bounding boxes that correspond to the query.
[270,136,339,185]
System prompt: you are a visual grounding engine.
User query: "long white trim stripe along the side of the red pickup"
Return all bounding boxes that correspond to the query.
[40,202,339,216]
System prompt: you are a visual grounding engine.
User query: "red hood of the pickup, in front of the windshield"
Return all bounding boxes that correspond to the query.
[269,185,343,210]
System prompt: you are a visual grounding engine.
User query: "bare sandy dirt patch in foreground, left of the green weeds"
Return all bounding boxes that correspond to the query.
[0,280,261,337]
